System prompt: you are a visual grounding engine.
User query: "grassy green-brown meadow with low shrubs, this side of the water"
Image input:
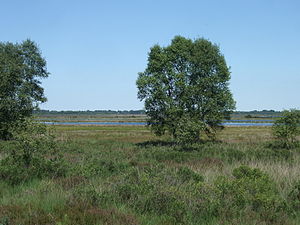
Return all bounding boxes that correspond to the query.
[0,126,300,225]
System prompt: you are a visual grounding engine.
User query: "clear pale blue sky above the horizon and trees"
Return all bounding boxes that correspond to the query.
[0,0,300,110]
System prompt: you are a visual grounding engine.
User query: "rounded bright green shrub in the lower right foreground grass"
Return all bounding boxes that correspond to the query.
[215,166,287,222]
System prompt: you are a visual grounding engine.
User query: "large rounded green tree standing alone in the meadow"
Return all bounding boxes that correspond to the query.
[136,36,235,142]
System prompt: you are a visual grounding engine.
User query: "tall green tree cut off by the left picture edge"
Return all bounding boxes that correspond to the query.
[0,40,49,139]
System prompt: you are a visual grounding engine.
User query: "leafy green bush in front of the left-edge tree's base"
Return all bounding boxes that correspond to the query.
[0,120,66,185]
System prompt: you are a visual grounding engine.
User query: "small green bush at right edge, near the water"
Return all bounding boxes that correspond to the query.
[272,110,300,148]
